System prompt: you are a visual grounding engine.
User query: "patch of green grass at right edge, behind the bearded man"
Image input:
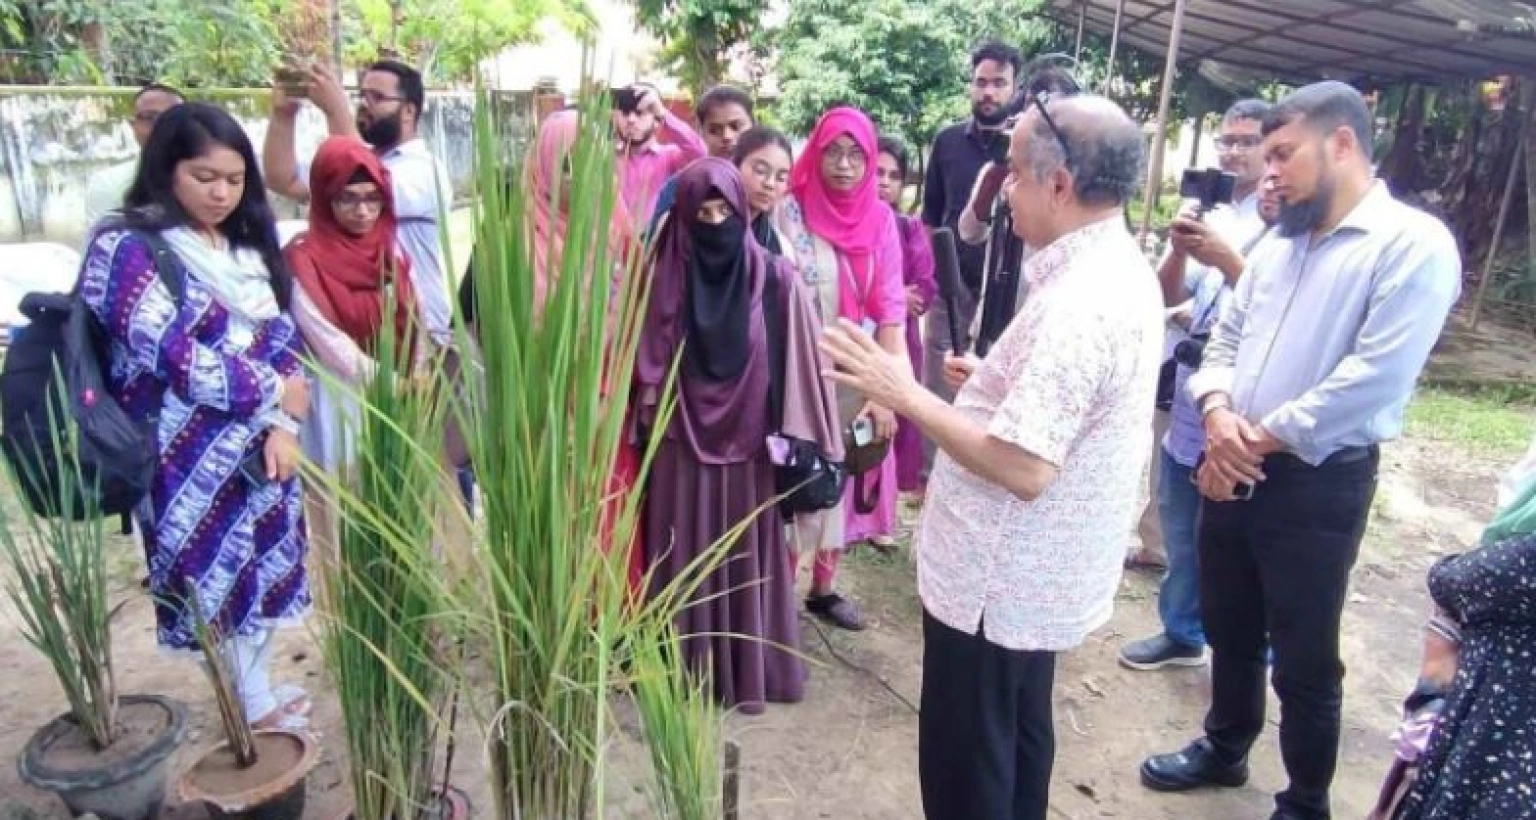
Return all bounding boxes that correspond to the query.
[1407,387,1536,458]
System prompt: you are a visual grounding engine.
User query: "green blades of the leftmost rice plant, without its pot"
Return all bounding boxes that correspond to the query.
[0,396,117,749]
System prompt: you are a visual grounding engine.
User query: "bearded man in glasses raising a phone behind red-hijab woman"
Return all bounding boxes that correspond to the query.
[263,60,453,346]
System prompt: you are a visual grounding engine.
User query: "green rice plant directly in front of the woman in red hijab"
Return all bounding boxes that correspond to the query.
[306,310,462,820]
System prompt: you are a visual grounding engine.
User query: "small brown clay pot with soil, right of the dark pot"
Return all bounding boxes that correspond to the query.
[177,729,319,820]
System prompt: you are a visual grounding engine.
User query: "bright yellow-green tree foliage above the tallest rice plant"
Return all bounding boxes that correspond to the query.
[346,0,596,81]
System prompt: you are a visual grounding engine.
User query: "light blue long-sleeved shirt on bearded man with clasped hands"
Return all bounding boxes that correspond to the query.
[1189,181,1461,465]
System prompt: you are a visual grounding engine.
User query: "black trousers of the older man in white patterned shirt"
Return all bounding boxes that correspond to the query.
[917,611,1055,820]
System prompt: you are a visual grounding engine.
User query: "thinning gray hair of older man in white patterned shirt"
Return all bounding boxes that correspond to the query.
[1025,94,1146,207]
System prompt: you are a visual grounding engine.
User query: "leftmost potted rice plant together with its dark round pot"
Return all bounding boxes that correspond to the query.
[0,433,186,820]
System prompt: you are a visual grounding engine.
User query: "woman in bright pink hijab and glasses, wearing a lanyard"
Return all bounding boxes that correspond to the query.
[777,107,906,630]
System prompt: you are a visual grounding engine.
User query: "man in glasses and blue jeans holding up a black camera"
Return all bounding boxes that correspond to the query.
[1120,100,1269,671]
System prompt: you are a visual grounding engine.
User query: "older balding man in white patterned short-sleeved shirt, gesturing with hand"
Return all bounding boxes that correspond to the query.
[822,95,1163,820]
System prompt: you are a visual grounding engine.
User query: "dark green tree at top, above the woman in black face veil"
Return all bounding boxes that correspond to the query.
[634,0,770,94]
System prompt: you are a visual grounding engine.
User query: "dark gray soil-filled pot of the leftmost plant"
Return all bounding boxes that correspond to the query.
[17,694,187,820]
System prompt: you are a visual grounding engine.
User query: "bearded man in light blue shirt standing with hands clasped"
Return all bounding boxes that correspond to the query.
[1141,83,1461,820]
